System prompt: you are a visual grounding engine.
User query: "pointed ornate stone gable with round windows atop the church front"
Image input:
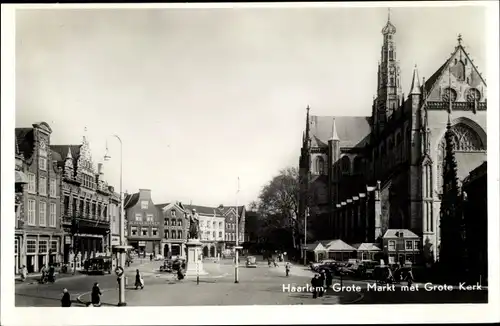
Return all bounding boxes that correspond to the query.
[425,36,487,110]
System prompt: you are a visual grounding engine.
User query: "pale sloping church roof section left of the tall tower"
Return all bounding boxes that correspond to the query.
[310,115,371,147]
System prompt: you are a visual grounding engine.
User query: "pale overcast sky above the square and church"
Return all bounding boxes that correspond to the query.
[16,6,486,206]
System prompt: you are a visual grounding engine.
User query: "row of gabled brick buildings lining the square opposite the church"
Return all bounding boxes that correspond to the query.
[14,122,245,274]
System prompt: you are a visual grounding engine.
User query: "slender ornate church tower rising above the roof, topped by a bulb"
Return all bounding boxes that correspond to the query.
[374,9,402,130]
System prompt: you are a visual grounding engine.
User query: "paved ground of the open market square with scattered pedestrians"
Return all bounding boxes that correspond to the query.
[16,259,488,307]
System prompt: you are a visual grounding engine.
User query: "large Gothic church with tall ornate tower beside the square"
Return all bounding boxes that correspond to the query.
[299,13,487,260]
